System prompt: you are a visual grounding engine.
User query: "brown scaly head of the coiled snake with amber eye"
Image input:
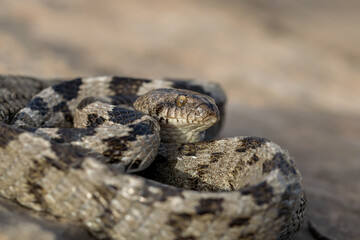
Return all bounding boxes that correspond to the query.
[134,88,220,143]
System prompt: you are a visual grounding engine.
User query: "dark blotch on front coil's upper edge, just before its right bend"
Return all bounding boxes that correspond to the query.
[241,181,273,205]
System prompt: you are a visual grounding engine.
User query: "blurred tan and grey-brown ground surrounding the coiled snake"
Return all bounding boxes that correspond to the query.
[0,0,360,239]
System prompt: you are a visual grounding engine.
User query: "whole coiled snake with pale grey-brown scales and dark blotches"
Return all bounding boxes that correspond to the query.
[0,75,306,240]
